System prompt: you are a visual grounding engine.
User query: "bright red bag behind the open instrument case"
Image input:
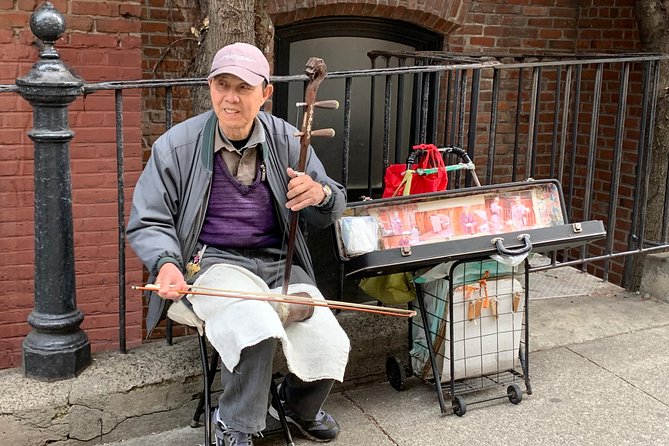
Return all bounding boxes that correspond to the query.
[382,144,448,198]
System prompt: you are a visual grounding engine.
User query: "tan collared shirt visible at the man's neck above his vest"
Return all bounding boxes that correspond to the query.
[214,116,265,186]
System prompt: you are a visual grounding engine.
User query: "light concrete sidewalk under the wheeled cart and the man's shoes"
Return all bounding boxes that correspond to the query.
[103,325,669,446]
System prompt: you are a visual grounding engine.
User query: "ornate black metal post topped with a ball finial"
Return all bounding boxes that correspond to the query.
[16,2,91,381]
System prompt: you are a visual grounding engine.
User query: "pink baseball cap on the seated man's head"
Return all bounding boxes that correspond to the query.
[207,43,269,86]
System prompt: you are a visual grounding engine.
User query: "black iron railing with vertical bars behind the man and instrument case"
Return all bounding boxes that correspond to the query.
[72,55,669,350]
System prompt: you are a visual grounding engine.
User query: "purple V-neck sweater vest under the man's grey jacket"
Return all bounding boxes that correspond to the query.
[200,154,281,248]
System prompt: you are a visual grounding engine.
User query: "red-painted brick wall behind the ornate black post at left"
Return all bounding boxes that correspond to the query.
[0,0,142,368]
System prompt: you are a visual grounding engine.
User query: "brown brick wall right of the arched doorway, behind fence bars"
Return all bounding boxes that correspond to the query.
[448,0,641,283]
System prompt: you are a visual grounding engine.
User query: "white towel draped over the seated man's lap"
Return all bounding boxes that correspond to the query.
[188,264,350,382]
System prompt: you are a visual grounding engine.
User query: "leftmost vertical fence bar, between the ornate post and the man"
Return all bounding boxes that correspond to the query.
[114,89,126,353]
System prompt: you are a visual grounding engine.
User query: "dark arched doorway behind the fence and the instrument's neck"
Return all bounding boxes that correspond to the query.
[272,17,443,301]
